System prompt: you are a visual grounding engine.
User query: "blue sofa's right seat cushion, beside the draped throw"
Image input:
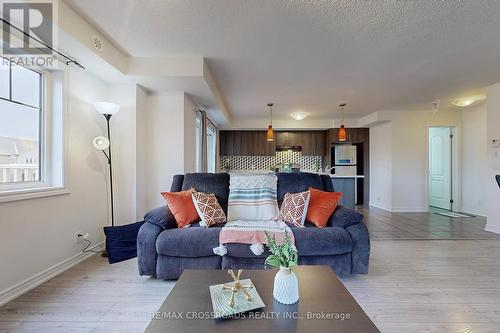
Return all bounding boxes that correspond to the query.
[292,227,353,256]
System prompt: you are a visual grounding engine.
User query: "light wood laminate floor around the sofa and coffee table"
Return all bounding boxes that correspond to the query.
[0,240,500,333]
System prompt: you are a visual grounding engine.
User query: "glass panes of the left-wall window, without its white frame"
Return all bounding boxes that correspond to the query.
[0,58,43,184]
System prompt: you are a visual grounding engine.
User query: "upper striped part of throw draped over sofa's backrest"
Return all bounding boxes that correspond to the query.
[227,175,279,221]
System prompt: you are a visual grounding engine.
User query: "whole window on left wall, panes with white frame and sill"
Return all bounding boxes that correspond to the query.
[0,57,68,202]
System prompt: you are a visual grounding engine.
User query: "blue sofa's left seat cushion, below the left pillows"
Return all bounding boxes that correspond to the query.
[156,223,221,258]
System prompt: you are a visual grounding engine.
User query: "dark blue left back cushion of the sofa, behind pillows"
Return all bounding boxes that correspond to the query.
[182,173,229,215]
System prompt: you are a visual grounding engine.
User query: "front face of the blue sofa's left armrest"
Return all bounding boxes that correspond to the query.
[137,222,163,276]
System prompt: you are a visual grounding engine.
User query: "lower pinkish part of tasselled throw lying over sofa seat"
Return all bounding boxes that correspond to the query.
[213,220,295,256]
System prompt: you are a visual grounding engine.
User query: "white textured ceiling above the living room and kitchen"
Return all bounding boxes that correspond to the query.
[66,0,500,119]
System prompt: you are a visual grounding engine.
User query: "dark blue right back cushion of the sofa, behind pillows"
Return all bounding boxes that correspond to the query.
[277,172,324,207]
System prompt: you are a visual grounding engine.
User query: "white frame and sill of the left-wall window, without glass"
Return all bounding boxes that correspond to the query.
[0,58,69,203]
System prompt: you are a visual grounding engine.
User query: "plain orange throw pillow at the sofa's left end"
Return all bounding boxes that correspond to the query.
[161,189,200,228]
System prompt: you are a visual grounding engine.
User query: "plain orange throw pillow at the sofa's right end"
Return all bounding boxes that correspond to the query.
[306,187,342,228]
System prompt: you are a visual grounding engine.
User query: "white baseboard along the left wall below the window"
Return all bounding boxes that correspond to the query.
[0,241,104,306]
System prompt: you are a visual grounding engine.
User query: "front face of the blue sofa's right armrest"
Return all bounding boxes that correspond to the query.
[346,223,370,274]
